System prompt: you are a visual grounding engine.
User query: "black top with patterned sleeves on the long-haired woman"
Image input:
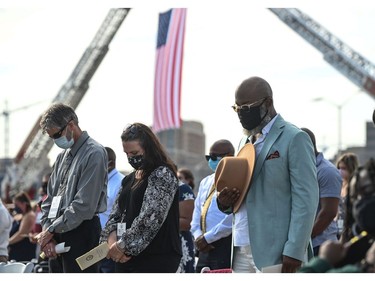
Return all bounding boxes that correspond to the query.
[107,167,182,273]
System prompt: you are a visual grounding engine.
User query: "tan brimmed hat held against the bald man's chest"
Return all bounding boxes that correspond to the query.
[215,143,255,213]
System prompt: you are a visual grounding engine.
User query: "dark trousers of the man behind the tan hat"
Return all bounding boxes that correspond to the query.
[195,235,232,273]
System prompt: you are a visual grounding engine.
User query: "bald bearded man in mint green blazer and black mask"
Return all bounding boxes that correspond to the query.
[218,77,319,273]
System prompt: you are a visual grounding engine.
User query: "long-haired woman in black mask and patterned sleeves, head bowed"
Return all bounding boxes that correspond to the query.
[100,123,182,273]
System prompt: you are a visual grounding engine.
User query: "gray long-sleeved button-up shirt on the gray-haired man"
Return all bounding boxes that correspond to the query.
[41,131,108,233]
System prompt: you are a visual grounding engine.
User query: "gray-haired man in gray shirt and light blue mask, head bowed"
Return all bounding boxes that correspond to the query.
[38,103,108,273]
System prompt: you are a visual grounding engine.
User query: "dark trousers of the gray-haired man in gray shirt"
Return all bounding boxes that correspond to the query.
[50,216,102,273]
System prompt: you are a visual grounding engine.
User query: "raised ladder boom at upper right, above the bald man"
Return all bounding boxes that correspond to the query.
[269,8,375,98]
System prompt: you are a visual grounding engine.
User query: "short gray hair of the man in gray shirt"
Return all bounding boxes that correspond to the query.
[39,103,78,134]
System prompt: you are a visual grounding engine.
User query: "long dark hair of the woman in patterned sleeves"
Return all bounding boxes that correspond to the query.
[121,123,177,179]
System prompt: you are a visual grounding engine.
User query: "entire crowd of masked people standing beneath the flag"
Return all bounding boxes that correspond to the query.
[0,77,375,273]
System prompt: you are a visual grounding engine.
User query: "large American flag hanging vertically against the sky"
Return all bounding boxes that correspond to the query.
[152,8,187,132]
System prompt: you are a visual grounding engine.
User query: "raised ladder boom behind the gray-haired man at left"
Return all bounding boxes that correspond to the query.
[2,8,130,195]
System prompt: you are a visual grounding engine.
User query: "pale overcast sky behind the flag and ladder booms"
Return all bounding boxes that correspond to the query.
[0,5,375,169]
